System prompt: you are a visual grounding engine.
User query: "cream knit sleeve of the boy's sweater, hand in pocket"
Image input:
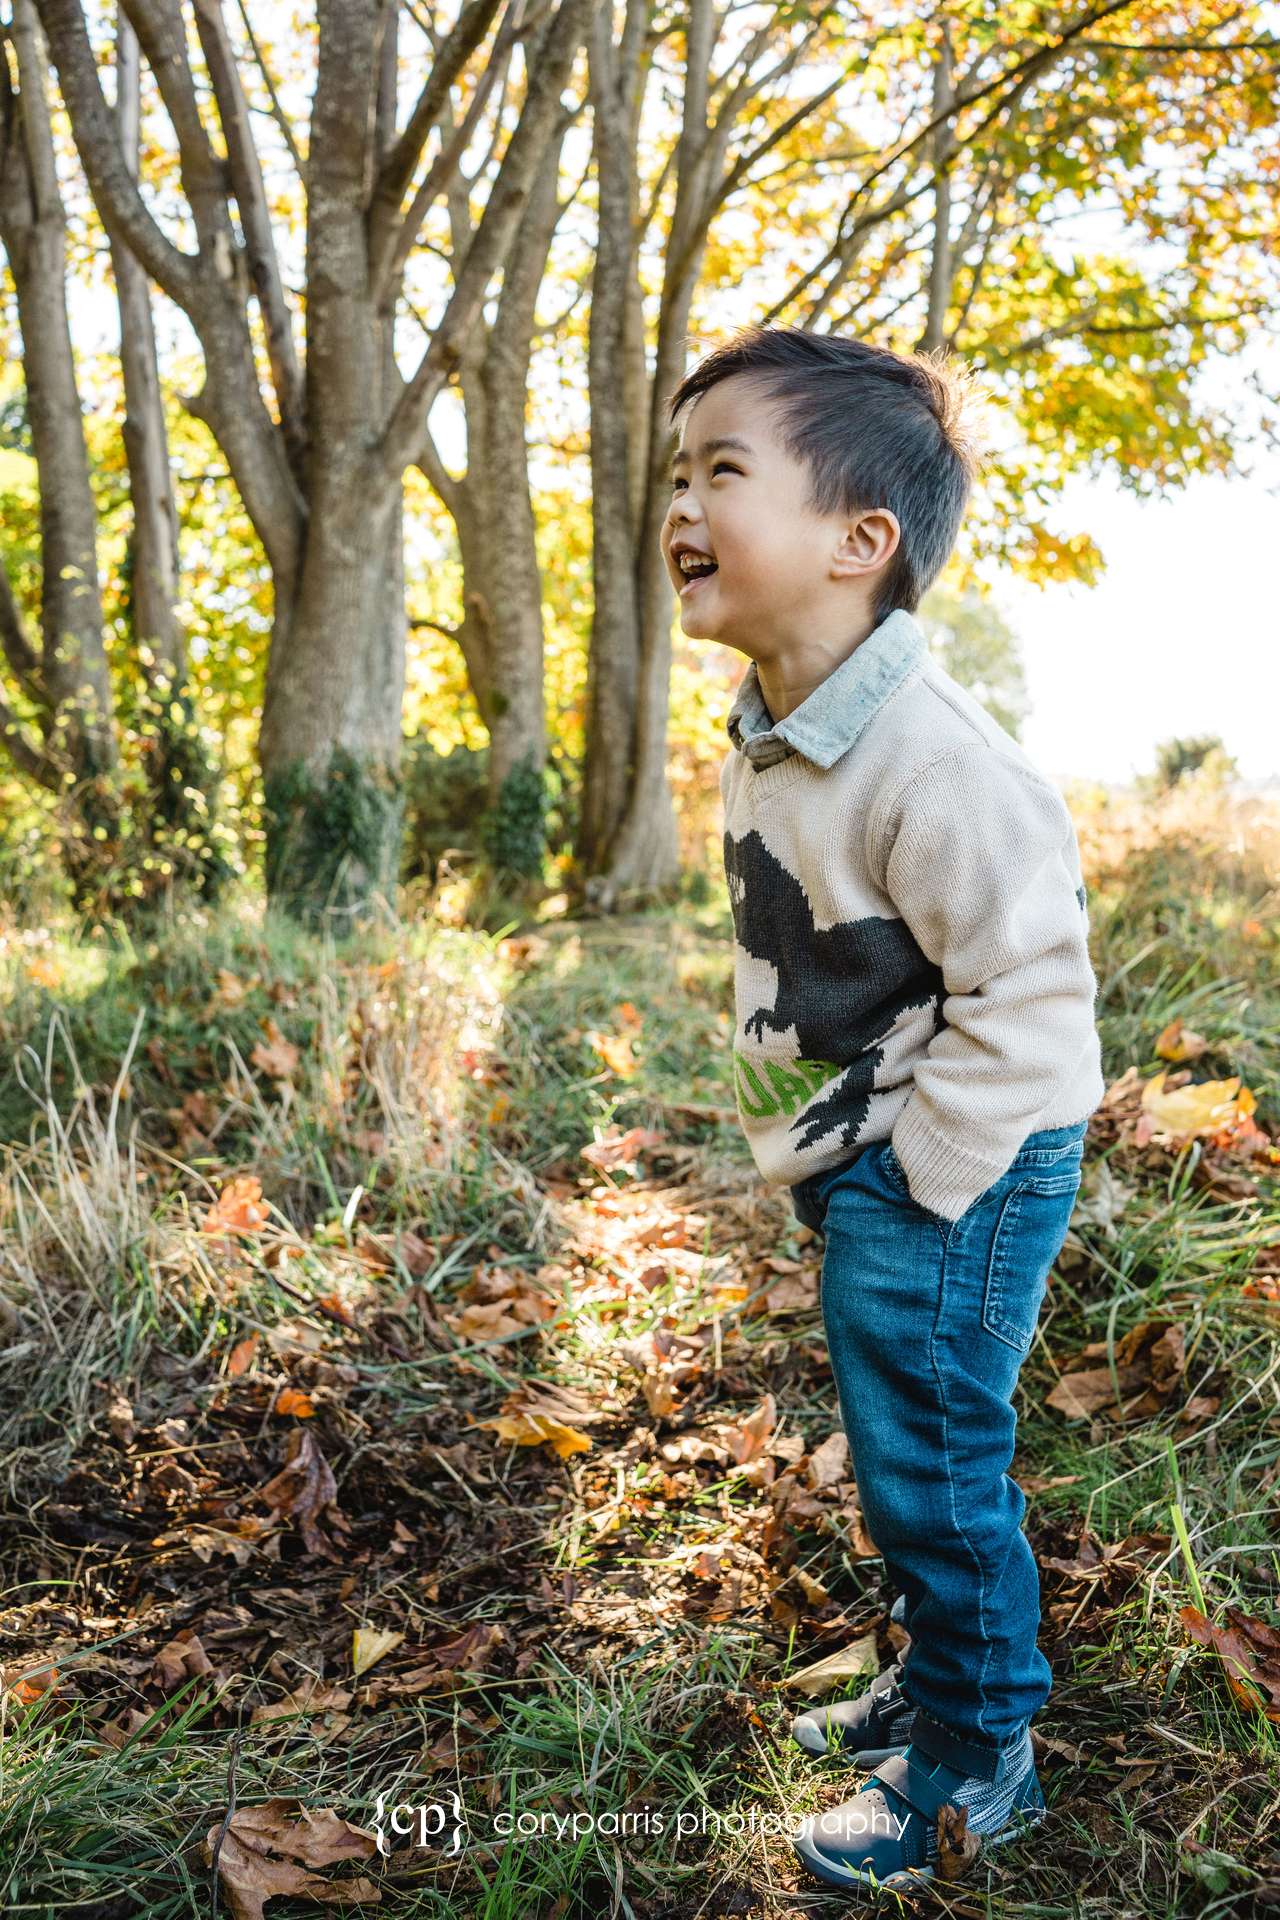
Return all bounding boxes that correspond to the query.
[883,743,1098,1219]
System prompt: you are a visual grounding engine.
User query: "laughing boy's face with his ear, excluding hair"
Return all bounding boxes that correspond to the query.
[662,374,896,660]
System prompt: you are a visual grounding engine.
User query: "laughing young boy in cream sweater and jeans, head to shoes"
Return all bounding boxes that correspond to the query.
[662,326,1105,1887]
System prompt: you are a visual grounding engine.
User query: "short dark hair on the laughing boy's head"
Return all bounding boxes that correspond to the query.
[668,326,977,620]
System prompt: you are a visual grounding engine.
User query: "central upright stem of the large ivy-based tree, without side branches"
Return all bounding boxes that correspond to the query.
[259,0,403,920]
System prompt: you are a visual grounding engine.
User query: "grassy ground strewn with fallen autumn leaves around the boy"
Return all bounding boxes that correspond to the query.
[0,783,1280,1920]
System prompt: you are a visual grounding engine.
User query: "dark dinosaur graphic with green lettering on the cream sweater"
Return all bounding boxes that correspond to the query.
[723,828,946,1152]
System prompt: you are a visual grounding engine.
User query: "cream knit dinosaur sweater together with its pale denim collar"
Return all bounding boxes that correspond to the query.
[720,611,1105,1219]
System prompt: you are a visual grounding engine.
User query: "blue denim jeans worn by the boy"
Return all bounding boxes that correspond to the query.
[791,1119,1088,1780]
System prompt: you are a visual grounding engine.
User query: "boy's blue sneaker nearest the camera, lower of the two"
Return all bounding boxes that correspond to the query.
[791,1732,1046,1891]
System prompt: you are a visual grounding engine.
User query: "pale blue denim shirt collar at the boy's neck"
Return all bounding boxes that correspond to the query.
[725,607,929,768]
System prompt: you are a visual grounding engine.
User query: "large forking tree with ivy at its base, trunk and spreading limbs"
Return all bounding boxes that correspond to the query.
[38,0,601,918]
